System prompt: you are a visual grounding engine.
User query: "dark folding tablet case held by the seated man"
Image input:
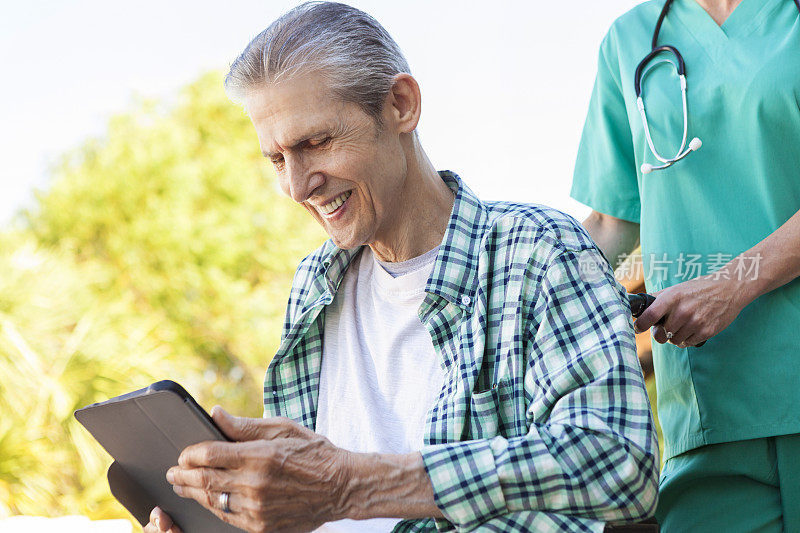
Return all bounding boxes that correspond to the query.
[75,382,242,533]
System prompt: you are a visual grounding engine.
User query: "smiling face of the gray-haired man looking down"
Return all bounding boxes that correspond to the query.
[245,74,407,248]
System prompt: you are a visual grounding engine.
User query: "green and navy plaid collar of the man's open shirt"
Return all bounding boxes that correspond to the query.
[317,170,488,309]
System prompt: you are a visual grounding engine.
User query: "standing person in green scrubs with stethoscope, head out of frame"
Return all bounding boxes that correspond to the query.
[571,0,800,532]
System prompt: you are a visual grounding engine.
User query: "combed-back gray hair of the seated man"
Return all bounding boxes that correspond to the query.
[225,2,410,124]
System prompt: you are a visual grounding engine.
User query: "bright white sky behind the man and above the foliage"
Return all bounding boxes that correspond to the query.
[0,0,638,224]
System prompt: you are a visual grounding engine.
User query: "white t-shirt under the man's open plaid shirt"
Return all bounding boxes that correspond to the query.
[316,246,444,533]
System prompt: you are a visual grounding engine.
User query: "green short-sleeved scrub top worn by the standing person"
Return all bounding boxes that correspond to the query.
[571,0,800,460]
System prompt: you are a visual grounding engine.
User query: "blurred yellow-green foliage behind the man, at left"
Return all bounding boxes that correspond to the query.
[0,73,325,518]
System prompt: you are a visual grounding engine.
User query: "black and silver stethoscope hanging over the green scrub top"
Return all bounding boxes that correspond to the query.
[633,0,800,174]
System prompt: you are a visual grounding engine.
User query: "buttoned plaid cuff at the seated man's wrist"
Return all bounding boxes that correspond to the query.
[421,437,507,531]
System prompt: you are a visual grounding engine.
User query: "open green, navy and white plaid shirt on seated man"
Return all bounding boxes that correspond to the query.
[264,171,658,532]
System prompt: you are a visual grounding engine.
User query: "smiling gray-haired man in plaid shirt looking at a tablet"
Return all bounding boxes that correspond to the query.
[145,3,658,532]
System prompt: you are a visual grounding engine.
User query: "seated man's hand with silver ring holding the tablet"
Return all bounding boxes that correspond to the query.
[162,407,351,532]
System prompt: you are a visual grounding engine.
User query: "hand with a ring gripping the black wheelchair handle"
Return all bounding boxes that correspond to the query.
[633,274,749,348]
